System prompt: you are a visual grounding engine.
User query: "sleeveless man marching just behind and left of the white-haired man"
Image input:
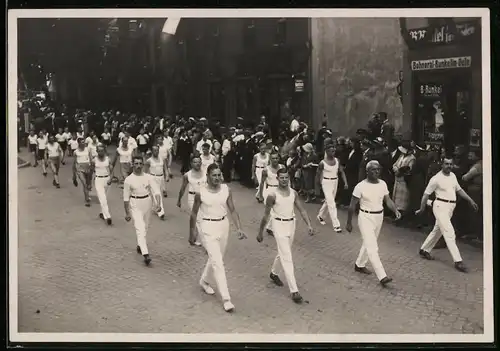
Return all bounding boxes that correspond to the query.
[316,143,348,233]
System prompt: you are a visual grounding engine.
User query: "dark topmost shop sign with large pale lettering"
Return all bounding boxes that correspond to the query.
[408,21,480,44]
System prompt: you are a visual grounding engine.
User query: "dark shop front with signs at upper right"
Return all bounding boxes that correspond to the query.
[403,20,482,151]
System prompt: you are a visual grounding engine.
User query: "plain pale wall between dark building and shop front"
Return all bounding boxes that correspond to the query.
[311,18,407,135]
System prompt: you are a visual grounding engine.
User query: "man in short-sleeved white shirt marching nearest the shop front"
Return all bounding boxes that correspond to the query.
[415,157,478,273]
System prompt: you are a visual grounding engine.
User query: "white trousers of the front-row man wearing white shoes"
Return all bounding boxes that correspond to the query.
[199,218,231,301]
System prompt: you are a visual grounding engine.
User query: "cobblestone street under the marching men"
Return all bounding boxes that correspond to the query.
[18,152,484,333]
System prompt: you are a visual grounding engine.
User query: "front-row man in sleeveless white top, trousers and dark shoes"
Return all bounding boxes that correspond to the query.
[257,168,314,303]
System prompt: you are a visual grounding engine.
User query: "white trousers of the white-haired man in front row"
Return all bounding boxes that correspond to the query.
[356,211,387,280]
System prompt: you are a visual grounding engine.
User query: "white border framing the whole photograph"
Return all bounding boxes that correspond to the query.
[7,8,495,344]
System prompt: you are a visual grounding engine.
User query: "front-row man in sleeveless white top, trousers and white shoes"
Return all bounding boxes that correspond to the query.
[189,163,246,312]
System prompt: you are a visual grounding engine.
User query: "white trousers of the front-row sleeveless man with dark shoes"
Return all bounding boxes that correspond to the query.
[271,219,299,293]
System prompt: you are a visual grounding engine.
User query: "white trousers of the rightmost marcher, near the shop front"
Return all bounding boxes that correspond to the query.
[421,200,462,262]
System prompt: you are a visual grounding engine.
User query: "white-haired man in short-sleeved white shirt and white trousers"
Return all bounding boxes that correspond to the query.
[346,160,401,287]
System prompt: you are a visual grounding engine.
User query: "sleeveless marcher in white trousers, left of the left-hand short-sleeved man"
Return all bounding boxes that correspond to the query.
[91,144,113,225]
